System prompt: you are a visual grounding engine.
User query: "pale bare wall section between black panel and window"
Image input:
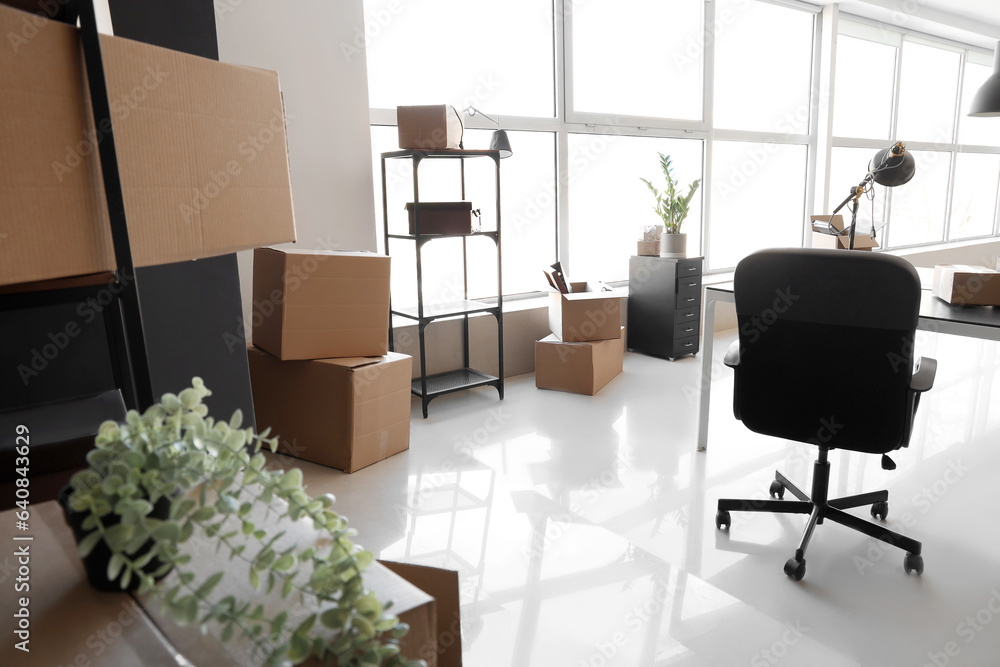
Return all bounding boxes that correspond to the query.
[215,0,376,327]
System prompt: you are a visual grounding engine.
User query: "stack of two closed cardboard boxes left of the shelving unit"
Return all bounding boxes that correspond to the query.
[248,248,412,472]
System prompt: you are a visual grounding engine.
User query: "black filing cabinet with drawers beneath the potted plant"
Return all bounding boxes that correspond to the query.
[627,257,702,360]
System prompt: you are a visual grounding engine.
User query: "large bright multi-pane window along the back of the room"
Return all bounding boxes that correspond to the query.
[364,0,1000,299]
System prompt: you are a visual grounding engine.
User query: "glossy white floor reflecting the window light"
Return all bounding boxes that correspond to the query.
[278,334,1000,667]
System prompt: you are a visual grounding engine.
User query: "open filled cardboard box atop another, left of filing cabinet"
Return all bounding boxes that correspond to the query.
[549,283,622,342]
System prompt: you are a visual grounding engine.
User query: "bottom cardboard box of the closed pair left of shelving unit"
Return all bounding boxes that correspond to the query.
[247,347,413,472]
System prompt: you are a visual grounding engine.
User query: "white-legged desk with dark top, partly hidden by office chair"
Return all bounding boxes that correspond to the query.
[698,283,1000,451]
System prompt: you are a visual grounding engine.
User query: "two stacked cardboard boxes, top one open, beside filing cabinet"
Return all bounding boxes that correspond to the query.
[535,283,625,396]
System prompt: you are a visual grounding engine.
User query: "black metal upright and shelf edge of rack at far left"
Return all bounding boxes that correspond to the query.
[0,0,153,410]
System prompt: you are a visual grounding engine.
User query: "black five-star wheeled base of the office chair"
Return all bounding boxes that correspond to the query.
[715,456,924,581]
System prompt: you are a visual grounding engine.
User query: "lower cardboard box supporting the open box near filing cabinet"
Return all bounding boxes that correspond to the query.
[535,328,625,396]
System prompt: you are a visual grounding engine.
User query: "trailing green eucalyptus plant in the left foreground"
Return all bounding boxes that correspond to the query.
[68,378,426,667]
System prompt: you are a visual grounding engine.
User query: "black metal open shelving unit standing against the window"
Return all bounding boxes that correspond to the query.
[382,150,504,418]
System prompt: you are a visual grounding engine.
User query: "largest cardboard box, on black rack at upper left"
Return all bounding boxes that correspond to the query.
[0,6,295,285]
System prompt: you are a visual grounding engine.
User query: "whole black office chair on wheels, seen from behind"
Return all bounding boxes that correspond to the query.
[715,248,937,581]
